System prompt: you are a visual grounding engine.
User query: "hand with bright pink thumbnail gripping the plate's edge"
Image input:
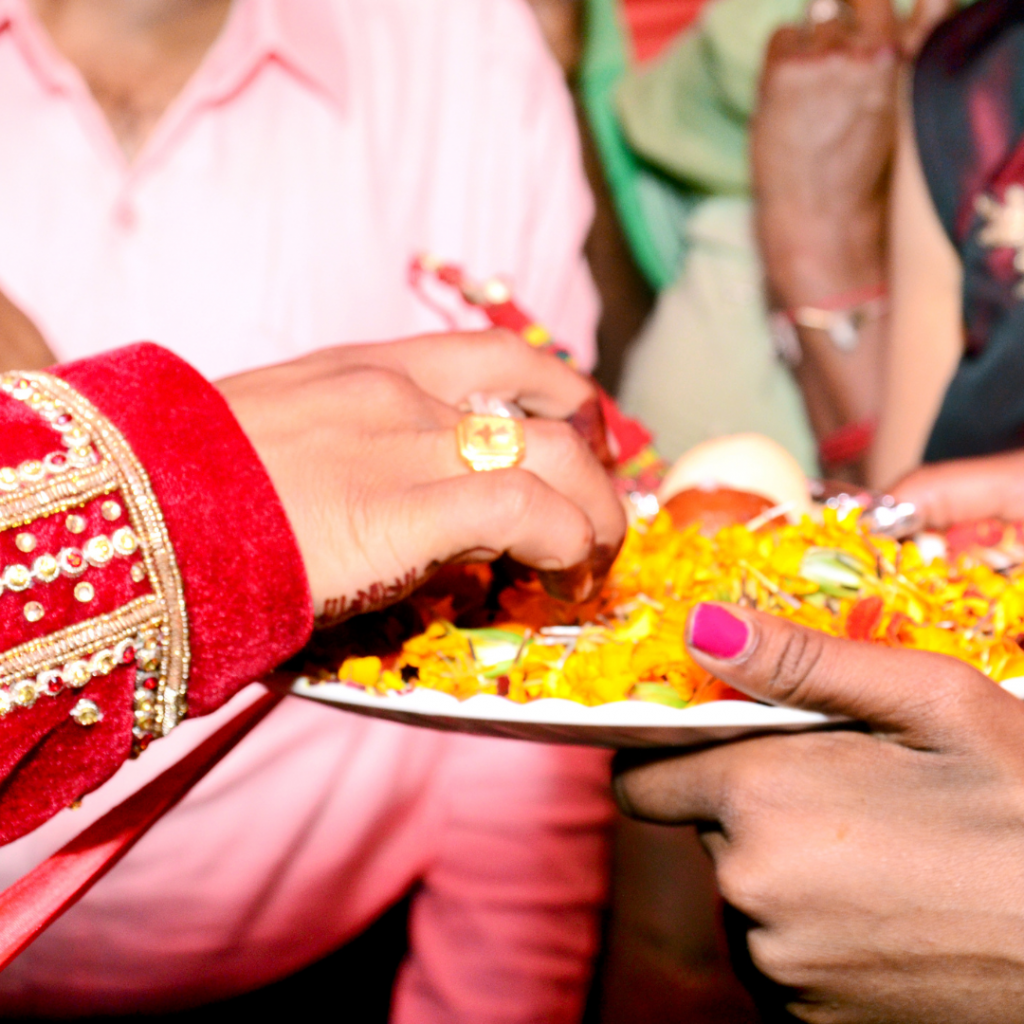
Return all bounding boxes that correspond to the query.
[615,605,1024,1024]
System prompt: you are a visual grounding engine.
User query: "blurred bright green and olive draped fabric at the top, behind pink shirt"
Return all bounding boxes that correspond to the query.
[580,0,912,291]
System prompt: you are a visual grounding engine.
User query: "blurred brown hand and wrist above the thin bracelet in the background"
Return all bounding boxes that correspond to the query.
[751,0,955,307]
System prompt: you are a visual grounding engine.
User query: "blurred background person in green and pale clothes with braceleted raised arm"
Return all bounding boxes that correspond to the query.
[581,0,951,478]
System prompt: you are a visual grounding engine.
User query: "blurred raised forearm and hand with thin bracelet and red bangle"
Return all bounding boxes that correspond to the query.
[751,0,953,479]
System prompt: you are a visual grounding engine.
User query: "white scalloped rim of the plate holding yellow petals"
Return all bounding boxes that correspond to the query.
[282,676,1024,748]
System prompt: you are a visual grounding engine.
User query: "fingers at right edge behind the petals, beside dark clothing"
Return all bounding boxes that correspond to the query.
[892,452,1024,529]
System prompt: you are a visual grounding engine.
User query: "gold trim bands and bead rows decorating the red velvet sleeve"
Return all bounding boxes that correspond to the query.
[0,373,189,753]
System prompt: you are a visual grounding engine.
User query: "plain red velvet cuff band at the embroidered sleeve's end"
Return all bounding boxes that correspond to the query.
[55,344,312,717]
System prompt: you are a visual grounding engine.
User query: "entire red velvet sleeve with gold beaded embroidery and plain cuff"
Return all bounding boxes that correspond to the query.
[0,345,312,842]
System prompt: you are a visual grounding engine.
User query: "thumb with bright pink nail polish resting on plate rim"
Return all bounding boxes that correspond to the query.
[686,603,998,746]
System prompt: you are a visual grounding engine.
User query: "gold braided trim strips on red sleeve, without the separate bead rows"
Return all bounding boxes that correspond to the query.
[0,372,190,738]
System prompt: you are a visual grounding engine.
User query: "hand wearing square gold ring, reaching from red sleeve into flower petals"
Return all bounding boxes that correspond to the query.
[218,332,626,622]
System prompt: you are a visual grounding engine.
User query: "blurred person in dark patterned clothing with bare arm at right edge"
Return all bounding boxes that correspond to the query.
[871,0,1024,485]
